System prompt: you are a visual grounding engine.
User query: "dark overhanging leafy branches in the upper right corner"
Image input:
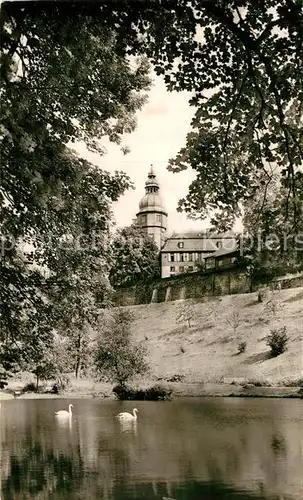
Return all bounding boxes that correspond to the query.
[92,0,303,229]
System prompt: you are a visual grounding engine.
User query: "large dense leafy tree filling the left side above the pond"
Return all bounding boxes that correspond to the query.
[0,2,149,376]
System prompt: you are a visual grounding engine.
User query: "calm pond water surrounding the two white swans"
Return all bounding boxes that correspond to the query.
[0,398,303,500]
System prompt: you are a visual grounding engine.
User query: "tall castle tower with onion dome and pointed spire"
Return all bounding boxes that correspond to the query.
[136,165,167,250]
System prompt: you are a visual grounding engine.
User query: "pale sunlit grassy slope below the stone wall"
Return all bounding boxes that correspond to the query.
[132,288,303,383]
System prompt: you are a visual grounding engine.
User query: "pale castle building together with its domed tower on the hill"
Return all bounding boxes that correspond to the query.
[136,167,237,278]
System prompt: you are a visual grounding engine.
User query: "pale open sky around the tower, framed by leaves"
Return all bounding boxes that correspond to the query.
[75,70,211,234]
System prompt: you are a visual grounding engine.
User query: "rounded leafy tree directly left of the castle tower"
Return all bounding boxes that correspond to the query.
[110,225,160,287]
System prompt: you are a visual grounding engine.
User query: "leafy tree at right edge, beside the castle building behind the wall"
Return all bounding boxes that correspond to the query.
[241,173,303,281]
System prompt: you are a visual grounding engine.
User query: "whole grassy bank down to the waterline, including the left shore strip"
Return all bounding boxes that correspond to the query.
[0,287,303,399]
